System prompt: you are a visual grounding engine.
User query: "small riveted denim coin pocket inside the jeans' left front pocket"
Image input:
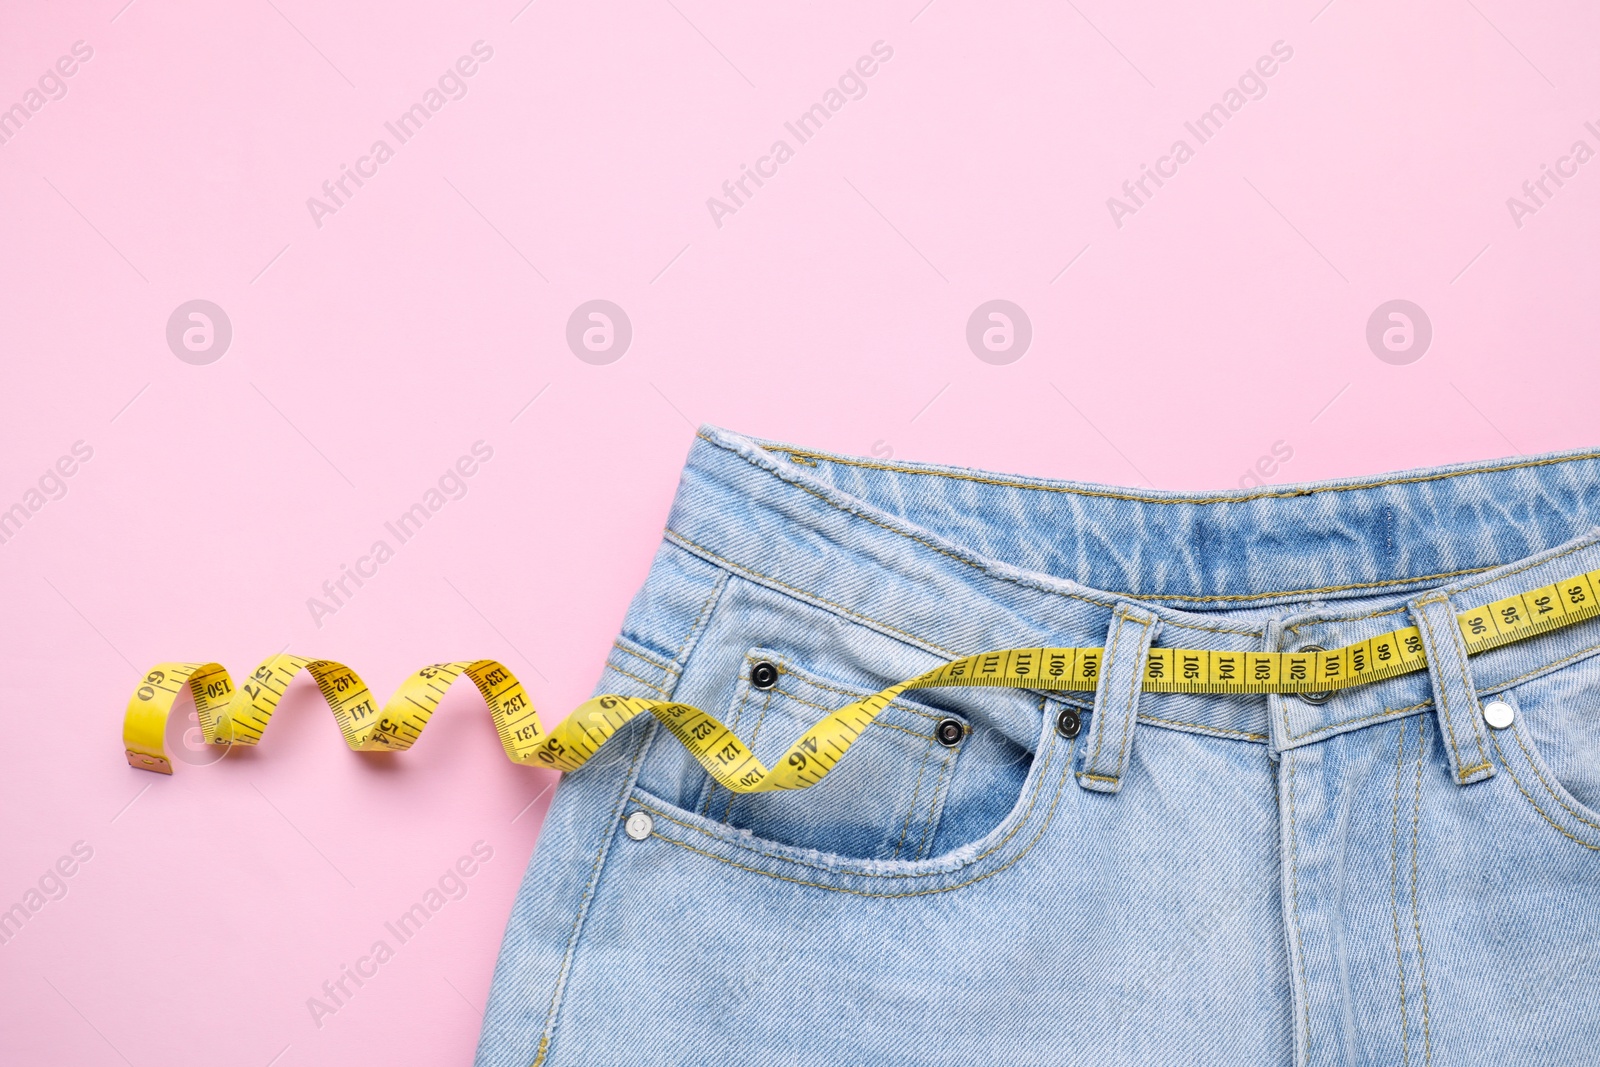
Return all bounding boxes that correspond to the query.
[694,648,968,859]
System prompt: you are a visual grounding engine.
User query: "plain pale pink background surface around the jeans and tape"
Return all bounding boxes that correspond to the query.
[0,0,1600,1067]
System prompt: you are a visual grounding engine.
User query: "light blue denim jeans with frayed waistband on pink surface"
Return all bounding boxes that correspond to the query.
[478,427,1600,1067]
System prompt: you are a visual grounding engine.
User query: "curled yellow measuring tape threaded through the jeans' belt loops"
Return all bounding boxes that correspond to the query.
[122,569,1600,793]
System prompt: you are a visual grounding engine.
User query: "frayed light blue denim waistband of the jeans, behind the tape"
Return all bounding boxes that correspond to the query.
[667,427,1600,749]
